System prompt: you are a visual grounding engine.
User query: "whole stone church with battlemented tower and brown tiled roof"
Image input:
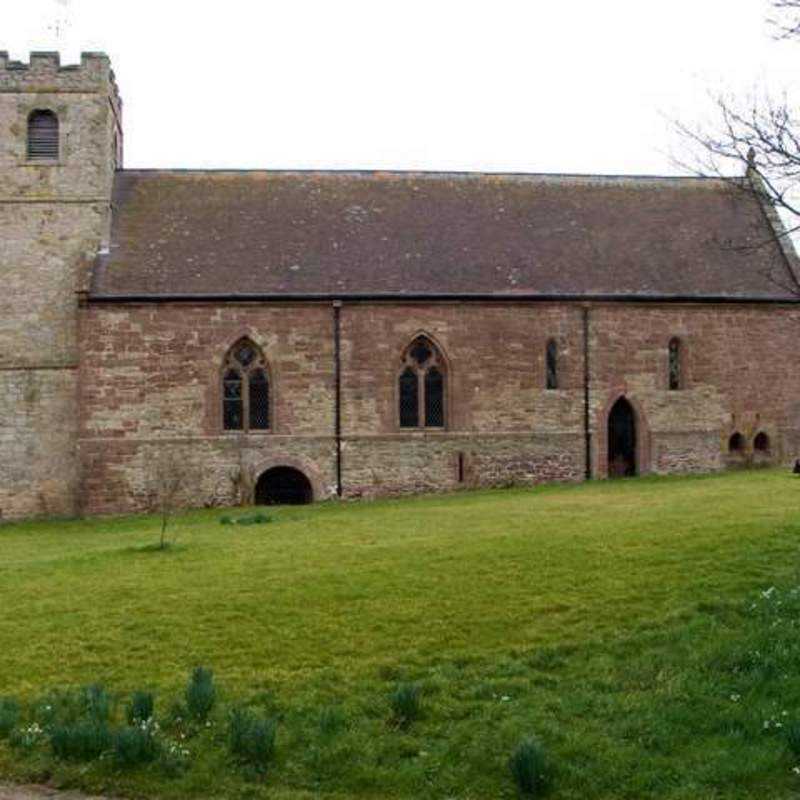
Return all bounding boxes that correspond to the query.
[0,53,800,519]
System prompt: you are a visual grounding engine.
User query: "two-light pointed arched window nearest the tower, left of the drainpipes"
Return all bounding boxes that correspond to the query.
[222,339,270,431]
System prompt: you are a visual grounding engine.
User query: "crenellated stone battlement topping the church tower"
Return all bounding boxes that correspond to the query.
[0,50,122,106]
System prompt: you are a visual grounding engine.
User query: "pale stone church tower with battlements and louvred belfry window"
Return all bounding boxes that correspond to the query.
[0,52,122,519]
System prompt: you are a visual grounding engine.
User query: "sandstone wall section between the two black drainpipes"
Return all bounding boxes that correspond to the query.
[341,303,584,496]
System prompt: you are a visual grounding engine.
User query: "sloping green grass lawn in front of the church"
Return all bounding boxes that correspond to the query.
[0,470,800,800]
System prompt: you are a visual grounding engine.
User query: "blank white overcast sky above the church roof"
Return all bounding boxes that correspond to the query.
[6,0,800,174]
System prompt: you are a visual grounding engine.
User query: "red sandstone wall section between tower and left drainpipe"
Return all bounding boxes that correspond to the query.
[80,304,336,513]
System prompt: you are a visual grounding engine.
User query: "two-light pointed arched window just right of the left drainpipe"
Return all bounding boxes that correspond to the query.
[398,336,447,428]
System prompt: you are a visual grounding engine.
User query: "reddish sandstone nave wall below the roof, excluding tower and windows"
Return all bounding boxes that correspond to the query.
[80,303,800,513]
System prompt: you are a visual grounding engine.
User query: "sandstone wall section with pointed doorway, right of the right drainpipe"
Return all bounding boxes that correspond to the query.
[590,304,800,477]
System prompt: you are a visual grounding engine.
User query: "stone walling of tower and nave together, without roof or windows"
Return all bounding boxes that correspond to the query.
[6,53,800,518]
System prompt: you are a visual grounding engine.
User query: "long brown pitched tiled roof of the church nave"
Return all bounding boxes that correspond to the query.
[91,170,790,299]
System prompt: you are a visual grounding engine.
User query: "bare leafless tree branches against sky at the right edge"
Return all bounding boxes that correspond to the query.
[677,0,800,255]
